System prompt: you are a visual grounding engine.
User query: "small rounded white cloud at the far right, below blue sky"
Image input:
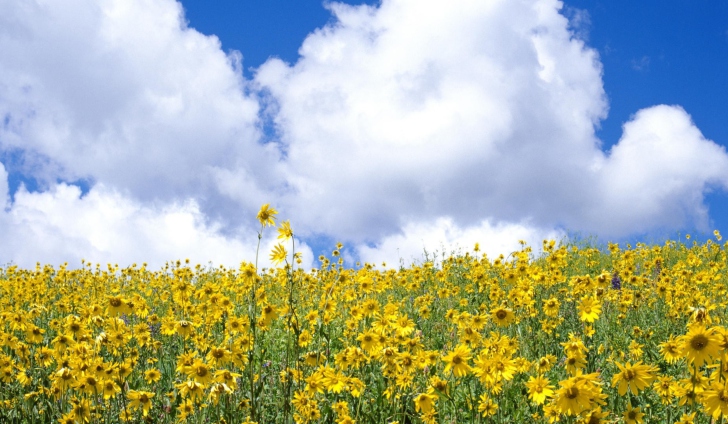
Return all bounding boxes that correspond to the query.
[580,105,728,235]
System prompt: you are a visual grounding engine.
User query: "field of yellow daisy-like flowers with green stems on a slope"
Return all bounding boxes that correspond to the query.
[0,205,728,424]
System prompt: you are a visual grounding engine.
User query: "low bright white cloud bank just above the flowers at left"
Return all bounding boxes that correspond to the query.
[0,165,313,269]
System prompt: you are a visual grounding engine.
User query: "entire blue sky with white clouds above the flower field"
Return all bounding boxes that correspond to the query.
[0,0,728,267]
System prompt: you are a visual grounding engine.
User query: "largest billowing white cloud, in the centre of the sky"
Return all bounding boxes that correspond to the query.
[256,0,606,240]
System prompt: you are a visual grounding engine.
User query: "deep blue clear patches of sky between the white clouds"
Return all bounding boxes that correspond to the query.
[182,0,728,248]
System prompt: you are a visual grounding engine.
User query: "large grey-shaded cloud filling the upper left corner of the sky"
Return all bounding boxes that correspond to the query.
[0,0,277,204]
